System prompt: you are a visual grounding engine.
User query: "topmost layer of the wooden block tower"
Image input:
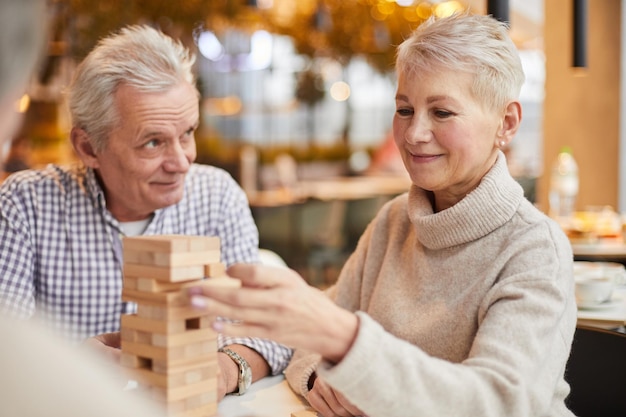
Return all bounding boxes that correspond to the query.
[122,235,220,253]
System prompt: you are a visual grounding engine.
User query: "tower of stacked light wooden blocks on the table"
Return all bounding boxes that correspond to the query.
[121,235,239,417]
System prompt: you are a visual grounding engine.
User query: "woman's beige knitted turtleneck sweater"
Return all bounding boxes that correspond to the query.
[286,154,576,417]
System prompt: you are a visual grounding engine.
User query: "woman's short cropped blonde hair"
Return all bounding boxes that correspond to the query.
[396,14,524,109]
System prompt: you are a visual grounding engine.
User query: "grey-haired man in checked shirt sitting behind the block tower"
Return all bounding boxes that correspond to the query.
[0,22,291,398]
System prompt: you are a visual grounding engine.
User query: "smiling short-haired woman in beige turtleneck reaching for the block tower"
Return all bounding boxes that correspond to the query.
[184,14,576,417]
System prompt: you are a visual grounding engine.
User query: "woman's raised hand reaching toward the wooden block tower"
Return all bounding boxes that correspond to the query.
[189,264,358,363]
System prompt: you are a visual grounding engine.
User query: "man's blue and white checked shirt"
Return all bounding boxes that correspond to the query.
[0,164,291,374]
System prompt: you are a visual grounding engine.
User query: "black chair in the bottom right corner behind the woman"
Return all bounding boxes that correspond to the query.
[565,325,626,417]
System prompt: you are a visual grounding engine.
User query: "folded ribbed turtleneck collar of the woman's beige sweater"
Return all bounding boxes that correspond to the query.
[408,152,524,250]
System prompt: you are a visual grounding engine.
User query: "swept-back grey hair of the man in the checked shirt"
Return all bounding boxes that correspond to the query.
[68,25,195,152]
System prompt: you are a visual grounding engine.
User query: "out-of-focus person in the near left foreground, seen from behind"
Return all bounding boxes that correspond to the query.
[0,0,162,417]
